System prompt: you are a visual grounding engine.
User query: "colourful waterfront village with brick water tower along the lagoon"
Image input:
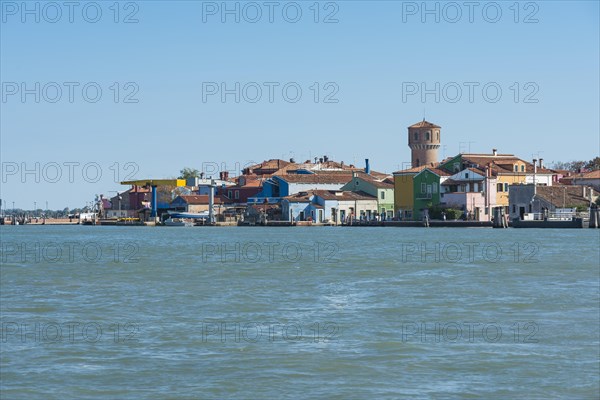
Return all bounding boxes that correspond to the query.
[4,120,600,227]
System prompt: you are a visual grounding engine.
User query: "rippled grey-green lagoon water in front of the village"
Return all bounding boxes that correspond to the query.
[0,226,600,399]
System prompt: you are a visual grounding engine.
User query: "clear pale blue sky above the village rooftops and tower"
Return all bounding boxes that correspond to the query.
[0,0,600,209]
